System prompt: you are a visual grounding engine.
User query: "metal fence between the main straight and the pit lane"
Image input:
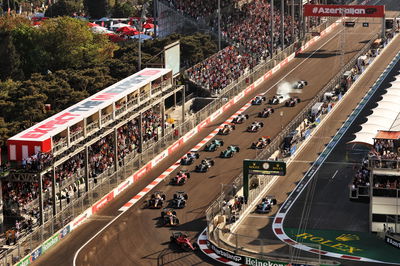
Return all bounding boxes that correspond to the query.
[206,31,378,262]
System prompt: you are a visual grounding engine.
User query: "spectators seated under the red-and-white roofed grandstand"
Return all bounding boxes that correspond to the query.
[2,109,162,224]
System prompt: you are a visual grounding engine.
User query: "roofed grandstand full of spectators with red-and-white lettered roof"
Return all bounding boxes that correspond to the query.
[2,68,184,229]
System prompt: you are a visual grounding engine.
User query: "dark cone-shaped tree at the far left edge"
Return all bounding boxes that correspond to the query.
[0,32,23,80]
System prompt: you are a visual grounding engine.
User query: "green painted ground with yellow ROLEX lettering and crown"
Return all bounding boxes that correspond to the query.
[284,228,400,263]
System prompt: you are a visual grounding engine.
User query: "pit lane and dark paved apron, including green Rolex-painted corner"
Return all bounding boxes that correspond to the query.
[233,36,400,265]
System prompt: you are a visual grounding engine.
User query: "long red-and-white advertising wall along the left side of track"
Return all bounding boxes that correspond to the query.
[16,16,344,266]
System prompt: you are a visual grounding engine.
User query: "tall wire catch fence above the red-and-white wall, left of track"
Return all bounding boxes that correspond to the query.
[0,17,340,265]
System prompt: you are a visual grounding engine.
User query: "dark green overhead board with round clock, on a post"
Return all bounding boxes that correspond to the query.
[243,159,286,201]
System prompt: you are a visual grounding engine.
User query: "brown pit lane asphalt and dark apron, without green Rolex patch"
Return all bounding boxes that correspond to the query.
[236,36,400,265]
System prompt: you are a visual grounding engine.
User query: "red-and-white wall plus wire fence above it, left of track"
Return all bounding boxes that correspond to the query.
[10,14,350,265]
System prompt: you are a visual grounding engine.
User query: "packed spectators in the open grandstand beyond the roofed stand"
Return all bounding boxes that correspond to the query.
[186,0,300,94]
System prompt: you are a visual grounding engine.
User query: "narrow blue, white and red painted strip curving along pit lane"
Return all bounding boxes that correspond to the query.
[272,49,400,263]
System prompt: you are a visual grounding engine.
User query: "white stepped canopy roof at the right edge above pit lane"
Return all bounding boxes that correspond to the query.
[349,72,400,145]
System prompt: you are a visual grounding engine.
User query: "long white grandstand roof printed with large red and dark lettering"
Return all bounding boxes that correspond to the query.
[9,68,171,141]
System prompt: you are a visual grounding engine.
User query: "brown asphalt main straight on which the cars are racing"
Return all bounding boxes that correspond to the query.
[35,18,378,266]
